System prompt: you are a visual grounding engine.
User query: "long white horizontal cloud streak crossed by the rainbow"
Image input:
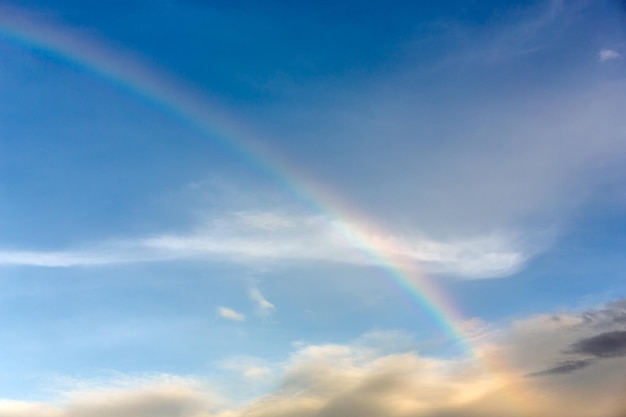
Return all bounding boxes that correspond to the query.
[0,212,537,278]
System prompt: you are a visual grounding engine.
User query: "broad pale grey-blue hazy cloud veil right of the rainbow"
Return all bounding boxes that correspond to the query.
[241,1,626,275]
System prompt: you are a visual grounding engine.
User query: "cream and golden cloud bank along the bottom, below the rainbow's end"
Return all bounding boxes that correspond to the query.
[0,302,626,417]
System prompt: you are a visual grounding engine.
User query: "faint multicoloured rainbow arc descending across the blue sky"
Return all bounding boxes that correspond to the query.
[0,9,468,357]
